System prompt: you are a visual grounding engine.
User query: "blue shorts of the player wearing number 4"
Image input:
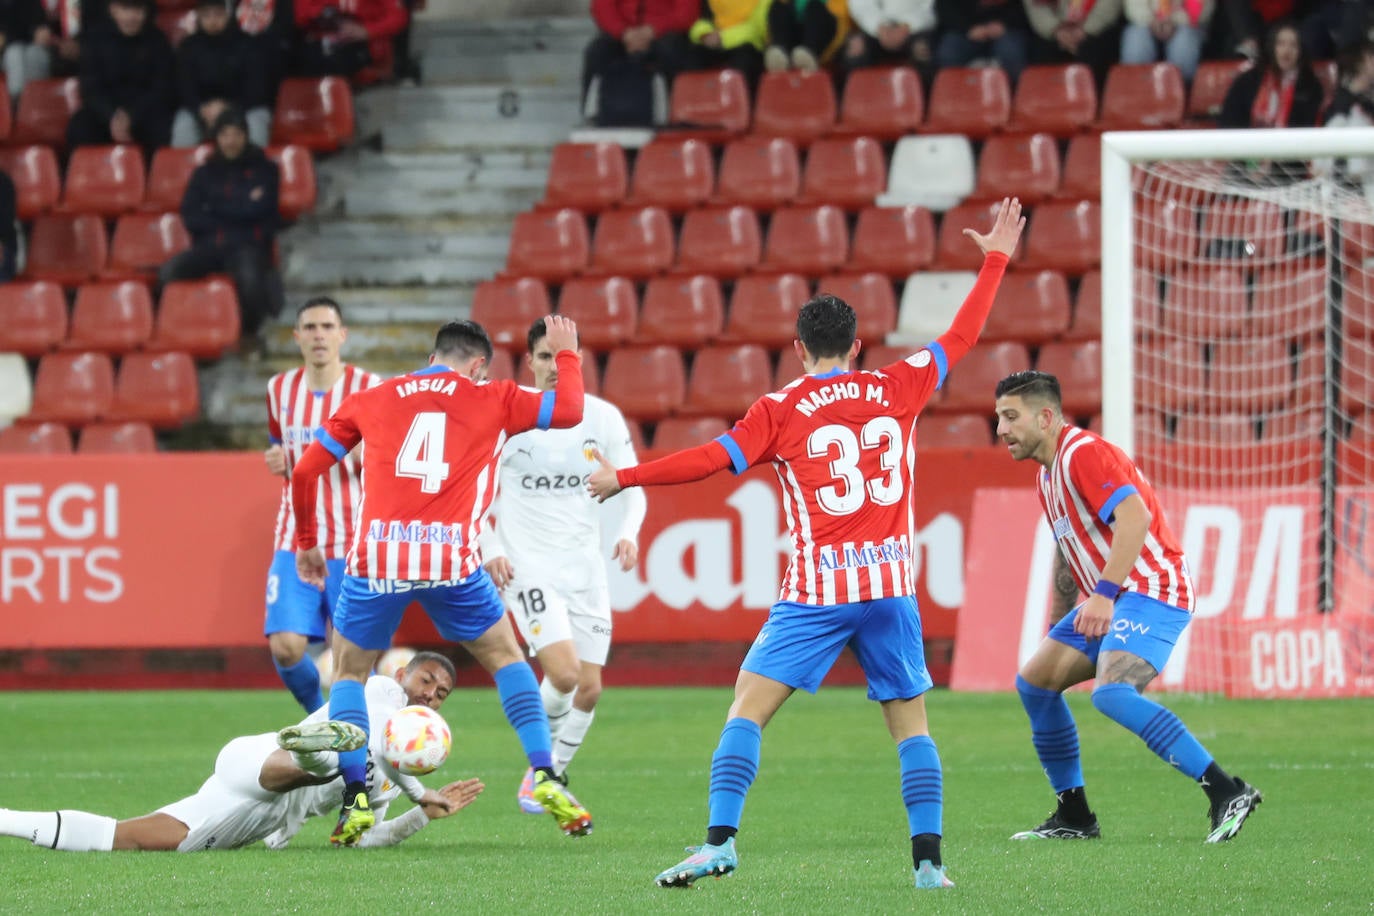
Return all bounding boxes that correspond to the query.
[334,570,506,650]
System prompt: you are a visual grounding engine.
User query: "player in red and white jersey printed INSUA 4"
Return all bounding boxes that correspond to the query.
[291,316,592,846]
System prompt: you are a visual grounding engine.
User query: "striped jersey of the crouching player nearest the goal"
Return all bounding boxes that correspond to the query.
[1037,426,1194,611]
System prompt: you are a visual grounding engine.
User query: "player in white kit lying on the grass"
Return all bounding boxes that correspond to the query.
[0,652,482,853]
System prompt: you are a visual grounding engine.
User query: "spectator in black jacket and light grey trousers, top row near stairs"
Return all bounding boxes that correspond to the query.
[172,0,272,147]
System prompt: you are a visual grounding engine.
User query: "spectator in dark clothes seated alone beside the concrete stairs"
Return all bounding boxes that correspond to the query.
[158,108,283,352]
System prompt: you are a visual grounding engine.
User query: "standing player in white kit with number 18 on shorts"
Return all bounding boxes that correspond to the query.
[481,319,644,814]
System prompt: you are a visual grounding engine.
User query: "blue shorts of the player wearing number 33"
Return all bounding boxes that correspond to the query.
[741,596,933,702]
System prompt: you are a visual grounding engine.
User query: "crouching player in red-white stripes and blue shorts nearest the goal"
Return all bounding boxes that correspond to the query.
[996,371,1261,843]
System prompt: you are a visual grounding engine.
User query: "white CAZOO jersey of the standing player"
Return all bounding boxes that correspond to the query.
[481,394,646,592]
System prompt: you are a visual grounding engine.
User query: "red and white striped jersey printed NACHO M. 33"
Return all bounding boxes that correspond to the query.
[717,343,947,604]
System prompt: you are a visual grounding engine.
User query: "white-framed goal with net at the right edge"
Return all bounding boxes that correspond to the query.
[1102,129,1374,696]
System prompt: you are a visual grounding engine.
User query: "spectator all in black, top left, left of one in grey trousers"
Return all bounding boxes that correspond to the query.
[67,0,176,157]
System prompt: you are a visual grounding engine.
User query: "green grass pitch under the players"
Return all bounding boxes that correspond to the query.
[0,688,1374,916]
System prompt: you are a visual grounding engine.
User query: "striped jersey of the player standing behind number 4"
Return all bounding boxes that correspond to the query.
[267,365,382,560]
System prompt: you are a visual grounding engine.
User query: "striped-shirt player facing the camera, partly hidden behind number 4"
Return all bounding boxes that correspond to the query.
[262,295,382,713]
